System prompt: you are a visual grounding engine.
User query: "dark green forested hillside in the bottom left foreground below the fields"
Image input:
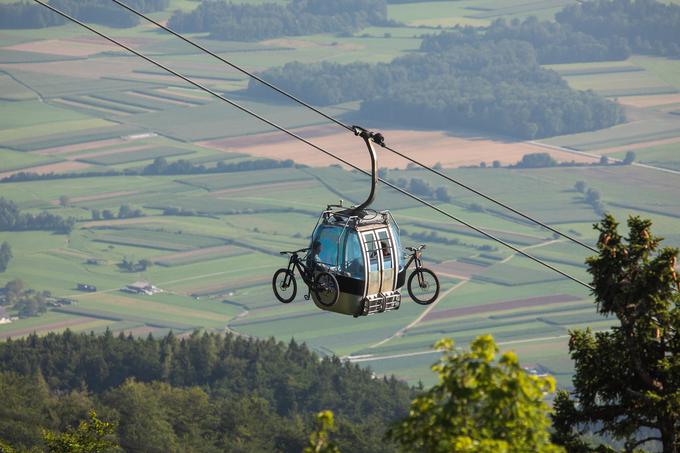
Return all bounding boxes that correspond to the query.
[0,331,413,452]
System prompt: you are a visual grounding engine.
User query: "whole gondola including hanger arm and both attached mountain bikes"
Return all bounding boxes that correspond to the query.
[272,126,439,317]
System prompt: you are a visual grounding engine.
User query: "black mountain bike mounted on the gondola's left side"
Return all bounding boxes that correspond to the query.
[272,248,340,307]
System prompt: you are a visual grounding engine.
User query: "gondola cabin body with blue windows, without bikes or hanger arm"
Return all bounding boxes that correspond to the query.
[307,206,405,316]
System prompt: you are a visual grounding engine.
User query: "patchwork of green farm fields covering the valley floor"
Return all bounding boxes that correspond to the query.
[0,0,680,386]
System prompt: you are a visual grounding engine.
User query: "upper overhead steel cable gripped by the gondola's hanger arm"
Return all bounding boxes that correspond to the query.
[106,0,598,253]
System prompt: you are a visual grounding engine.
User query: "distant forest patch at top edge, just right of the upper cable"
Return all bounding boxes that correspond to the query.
[168,0,390,41]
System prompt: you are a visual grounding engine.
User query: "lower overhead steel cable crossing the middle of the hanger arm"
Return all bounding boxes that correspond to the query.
[33,0,594,290]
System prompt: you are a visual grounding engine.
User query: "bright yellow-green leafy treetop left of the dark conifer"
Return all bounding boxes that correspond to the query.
[388,335,561,453]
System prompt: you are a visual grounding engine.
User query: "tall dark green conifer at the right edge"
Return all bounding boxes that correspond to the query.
[555,215,680,452]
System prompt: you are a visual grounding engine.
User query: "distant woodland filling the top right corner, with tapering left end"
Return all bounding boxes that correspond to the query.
[421,0,680,64]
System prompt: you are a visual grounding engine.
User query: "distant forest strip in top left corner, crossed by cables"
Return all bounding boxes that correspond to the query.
[0,0,170,28]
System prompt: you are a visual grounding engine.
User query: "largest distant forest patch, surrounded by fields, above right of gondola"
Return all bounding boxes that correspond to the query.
[248,40,623,139]
